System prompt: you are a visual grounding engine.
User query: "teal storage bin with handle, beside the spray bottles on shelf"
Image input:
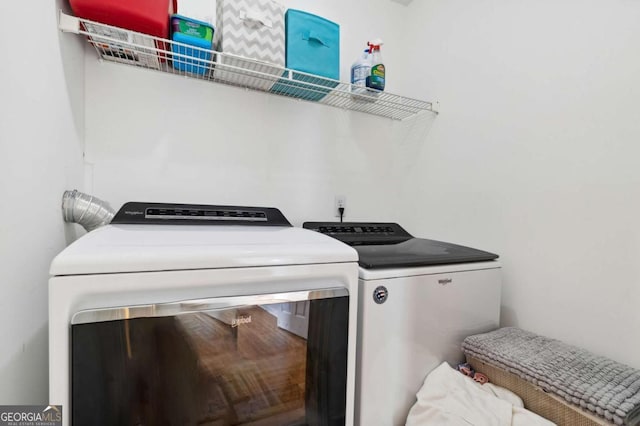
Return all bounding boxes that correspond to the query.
[271,9,340,101]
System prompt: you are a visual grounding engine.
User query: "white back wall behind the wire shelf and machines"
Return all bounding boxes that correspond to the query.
[86,0,430,224]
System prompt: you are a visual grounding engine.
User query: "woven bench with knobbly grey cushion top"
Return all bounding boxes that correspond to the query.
[462,327,640,426]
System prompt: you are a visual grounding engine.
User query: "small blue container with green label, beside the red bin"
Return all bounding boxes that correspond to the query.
[171,15,214,74]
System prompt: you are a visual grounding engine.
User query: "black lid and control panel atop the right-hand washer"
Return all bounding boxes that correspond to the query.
[302,222,498,269]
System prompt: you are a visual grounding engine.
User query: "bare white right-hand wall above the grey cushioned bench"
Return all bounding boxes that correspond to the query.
[399,0,640,367]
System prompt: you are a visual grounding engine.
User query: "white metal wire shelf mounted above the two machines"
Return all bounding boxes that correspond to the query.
[59,12,437,120]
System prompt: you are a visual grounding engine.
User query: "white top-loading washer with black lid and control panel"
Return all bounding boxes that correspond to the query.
[304,222,501,426]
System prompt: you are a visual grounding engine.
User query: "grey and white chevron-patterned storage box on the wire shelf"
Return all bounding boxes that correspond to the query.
[214,0,285,90]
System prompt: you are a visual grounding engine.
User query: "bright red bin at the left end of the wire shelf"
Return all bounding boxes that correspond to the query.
[69,0,178,38]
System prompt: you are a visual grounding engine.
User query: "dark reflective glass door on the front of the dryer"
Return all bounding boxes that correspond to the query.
[71,288,349,426]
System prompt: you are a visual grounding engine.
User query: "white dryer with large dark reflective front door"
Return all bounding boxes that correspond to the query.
[49,203,358,426]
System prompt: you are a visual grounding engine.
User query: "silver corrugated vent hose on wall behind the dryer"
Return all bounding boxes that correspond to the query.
[62,189,116,232]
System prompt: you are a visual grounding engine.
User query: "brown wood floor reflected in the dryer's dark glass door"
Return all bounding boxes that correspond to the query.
[175,307,307,426]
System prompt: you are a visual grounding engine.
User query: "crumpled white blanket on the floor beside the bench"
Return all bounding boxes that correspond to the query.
[407,362,555,426]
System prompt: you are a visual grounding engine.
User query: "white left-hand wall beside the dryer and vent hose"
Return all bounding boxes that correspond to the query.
[0,1,84,404]
